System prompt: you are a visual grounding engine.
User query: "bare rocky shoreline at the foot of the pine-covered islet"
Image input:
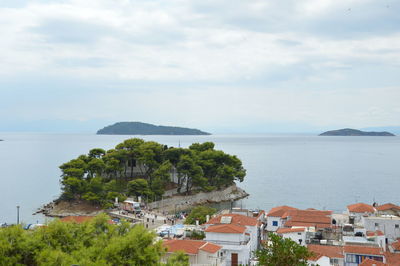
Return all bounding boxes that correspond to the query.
[35,184,249,217]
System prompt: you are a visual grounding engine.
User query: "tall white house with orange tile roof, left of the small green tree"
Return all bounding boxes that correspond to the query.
[204,213,262,265]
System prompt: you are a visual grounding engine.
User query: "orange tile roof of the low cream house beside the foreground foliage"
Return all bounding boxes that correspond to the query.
[163,239,222,254]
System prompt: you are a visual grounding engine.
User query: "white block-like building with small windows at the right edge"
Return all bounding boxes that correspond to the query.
[362,215,400,240]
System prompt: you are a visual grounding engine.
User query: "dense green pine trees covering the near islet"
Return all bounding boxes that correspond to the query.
[55,138,246,208]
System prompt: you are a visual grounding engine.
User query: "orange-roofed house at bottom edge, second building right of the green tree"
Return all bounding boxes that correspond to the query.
[343,245,386,266]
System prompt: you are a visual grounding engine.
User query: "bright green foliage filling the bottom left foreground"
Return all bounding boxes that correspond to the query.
[0,215,177,266]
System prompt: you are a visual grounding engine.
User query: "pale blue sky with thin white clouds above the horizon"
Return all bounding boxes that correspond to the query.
[0,0,400,133]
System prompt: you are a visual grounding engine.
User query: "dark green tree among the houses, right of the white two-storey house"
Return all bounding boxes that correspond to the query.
[255,233,312,266]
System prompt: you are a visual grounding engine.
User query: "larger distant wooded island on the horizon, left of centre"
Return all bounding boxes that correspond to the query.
[97,122,211,135]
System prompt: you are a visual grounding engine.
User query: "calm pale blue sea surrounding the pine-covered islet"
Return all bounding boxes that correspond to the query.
[0,133,400,223]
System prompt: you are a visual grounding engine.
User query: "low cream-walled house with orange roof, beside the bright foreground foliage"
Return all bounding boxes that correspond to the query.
[163,239,225,266]
